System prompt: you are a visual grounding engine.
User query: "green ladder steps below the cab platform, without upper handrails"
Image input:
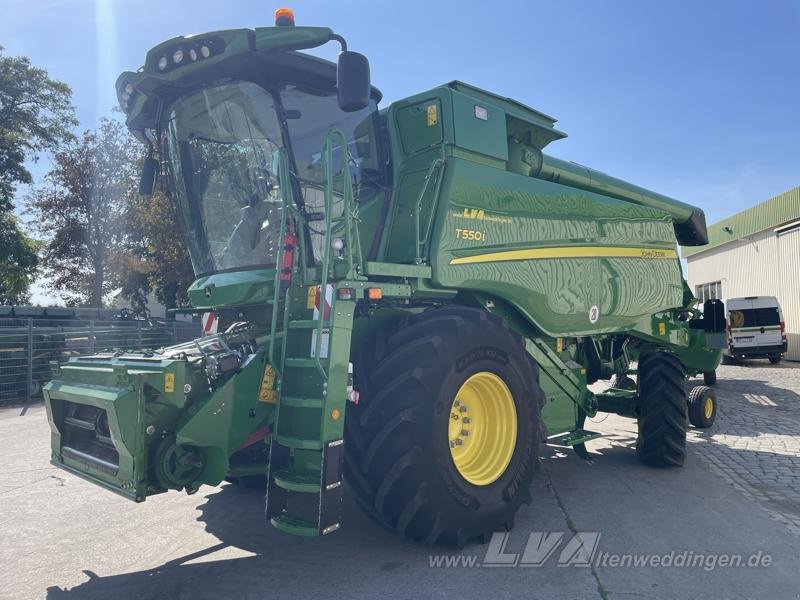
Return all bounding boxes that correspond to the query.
[266,285,355,537]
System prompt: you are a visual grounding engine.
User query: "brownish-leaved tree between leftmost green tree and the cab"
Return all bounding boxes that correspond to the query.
[29,119,141,307]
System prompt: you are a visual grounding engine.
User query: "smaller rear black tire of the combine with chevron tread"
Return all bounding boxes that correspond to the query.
[636,351,687,467]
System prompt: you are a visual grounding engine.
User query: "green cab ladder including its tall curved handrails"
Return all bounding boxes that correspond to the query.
[266,129,362,537]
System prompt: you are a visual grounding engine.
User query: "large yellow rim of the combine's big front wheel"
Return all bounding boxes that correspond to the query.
[448,371,517,485]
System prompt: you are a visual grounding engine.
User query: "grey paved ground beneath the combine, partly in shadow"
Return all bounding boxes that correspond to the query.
[0,361,800,600]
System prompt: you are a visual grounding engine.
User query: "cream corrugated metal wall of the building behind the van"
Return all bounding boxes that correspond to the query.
[686,224,800,360]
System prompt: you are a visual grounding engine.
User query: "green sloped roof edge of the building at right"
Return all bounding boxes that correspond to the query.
[681,187,800,258]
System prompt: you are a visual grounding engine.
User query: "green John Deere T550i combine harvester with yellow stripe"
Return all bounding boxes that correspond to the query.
[45,9,724,545]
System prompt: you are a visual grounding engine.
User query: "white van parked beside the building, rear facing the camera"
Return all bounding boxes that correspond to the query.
[725,296,786,364]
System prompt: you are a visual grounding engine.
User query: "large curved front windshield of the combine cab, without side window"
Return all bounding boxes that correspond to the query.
[167,82,281,274]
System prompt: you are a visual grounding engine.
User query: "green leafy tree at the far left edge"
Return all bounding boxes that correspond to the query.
[0,46,77,304]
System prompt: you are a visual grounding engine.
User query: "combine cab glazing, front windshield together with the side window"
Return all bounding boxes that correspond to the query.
[165,81,381,275]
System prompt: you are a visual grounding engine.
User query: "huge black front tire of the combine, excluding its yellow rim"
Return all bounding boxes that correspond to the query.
[345,306,543,547]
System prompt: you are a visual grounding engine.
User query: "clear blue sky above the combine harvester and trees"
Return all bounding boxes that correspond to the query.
[0,0,800,300]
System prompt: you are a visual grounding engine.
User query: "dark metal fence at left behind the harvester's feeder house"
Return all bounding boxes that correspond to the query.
[0,318,201,405]
